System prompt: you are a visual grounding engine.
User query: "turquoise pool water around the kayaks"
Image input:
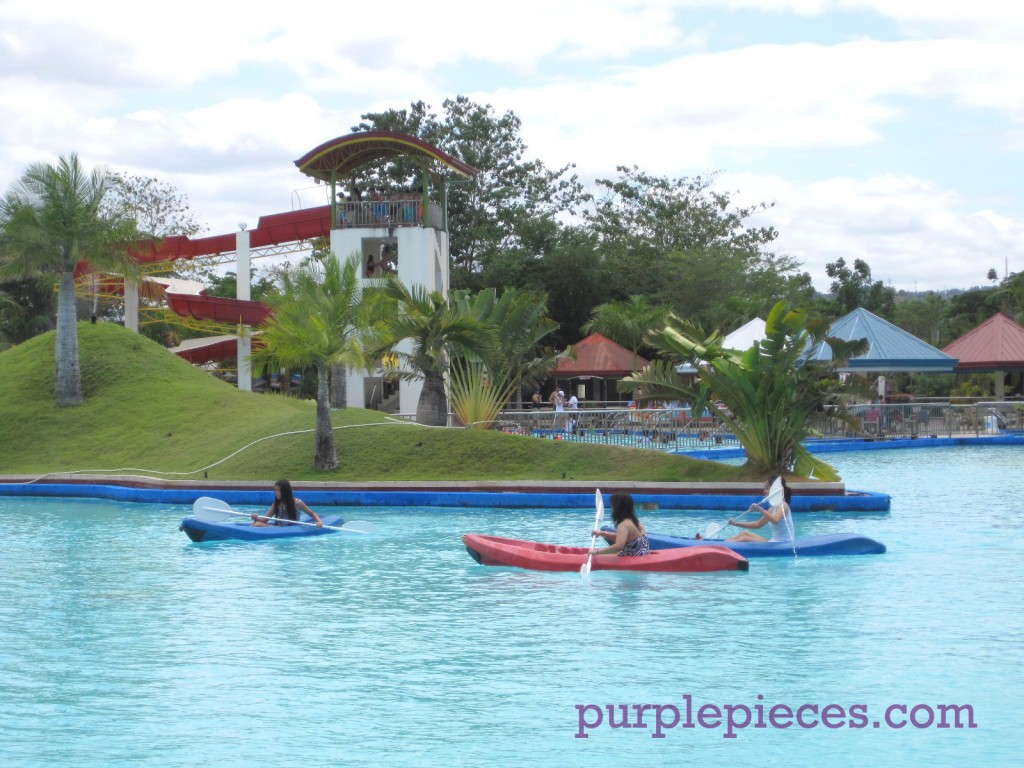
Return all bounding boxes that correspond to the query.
[0,446,1024,768]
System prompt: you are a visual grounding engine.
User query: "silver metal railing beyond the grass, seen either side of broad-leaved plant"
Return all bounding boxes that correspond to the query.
[495,401,1024,451]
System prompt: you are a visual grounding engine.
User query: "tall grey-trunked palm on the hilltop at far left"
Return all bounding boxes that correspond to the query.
[0,155,138,406]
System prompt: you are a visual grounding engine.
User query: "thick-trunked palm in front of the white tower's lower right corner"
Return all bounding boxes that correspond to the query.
[369,276,496,426]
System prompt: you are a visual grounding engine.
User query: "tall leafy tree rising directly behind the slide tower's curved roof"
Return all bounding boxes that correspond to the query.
[352,96,587,290]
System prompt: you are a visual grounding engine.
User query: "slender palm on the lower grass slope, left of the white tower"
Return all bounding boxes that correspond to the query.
[253,254,367,470]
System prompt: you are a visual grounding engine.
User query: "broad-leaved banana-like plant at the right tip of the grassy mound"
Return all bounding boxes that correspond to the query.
[620,301,867,480]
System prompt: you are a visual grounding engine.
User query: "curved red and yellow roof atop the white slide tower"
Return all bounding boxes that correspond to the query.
[295,131,479,181]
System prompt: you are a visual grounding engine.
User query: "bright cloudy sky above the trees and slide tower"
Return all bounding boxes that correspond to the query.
[0,0,1024,291]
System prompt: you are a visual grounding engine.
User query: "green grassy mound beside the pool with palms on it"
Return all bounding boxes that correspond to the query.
[0,324,751,482]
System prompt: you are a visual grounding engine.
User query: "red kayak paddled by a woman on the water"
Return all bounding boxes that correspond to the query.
[462,534,750,572]
